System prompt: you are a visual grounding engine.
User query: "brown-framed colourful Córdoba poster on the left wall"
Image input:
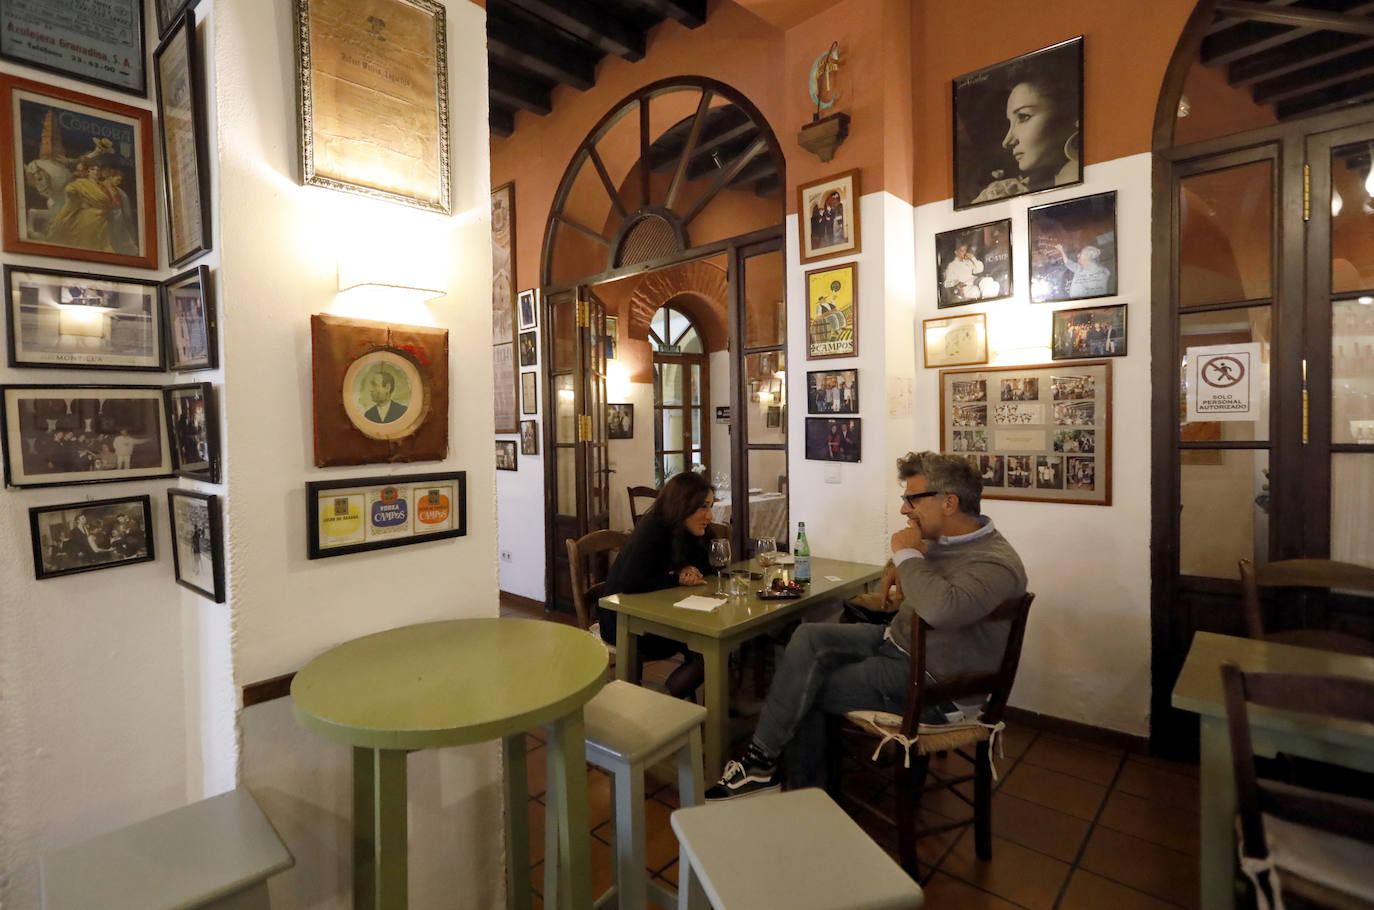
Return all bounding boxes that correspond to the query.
[0,75,158,268]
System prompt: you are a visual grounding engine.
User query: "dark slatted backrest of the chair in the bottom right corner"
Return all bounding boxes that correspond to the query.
[1221,664,1374,858]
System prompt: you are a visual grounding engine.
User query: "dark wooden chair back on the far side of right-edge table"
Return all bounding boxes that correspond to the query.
[1241,559,1374,657]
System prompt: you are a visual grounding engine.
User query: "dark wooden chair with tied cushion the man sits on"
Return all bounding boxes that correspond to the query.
[827,594,1035,877]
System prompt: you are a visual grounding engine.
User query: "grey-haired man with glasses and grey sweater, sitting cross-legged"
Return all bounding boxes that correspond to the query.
[706,452,1026,800]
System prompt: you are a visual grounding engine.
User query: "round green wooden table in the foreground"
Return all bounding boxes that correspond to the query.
[291,619,607,910]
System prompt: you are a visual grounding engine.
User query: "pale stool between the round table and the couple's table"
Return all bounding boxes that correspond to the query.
[544,680,706,910]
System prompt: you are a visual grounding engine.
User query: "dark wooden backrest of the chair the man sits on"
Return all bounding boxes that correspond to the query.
[901,591,1035,737]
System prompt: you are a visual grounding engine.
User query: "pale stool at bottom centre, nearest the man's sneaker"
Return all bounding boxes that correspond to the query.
[672,789,925,910]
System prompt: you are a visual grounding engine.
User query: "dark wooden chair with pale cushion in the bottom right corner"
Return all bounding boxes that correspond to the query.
[1221,664,1374,910]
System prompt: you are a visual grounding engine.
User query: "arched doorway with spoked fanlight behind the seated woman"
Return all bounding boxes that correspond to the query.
[540,76,786,605]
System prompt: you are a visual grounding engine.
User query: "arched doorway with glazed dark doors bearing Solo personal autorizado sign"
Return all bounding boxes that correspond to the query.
[1151,0,1374,755]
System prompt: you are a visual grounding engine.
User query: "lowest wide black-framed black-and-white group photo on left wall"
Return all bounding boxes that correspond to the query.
[29,493,153,580]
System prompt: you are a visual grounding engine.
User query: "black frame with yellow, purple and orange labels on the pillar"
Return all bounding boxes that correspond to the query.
[305,472,467,559]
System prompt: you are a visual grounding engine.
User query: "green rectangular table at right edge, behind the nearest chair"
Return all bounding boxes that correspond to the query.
[1173,632,1374,910]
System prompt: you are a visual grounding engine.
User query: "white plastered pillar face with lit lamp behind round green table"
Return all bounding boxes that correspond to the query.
[214,0,503,909]
